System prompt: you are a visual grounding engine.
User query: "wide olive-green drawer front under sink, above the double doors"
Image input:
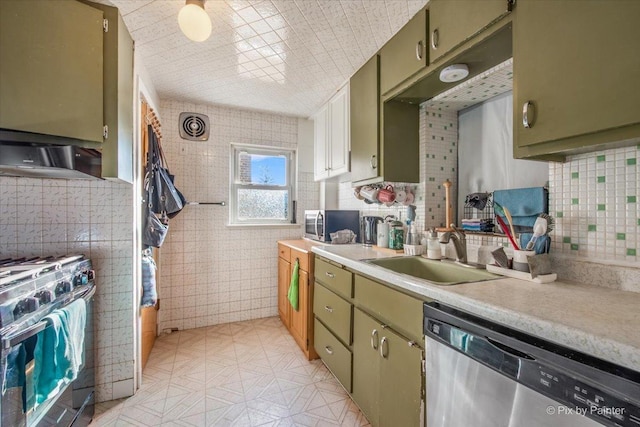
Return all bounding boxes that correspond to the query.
[355,275,423,342]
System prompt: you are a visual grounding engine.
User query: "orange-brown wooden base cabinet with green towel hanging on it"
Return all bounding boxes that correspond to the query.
[278,240,318,360]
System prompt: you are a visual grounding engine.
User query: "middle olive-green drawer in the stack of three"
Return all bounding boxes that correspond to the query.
[313,285,353,345]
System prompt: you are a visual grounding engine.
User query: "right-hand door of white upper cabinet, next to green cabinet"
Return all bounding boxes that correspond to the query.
[329,85,350,176]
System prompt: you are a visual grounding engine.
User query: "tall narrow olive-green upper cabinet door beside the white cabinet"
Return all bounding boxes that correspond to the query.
[349,55,380,182]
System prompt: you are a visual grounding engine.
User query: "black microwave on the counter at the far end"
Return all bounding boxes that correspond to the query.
[304,209,361,242]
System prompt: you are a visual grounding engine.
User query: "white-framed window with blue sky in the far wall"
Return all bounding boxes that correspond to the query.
[229,144,295,225]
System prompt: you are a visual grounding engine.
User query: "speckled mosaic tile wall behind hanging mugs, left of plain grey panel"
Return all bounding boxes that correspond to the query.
[338,108,458,234]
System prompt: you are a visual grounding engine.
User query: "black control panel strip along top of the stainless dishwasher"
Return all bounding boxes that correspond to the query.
[424,304,640,427]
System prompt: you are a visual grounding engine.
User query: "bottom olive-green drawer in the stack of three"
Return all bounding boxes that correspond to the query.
[314,319,352,393]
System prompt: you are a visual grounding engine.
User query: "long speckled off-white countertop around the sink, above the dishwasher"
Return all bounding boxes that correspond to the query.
[312,245,640,372]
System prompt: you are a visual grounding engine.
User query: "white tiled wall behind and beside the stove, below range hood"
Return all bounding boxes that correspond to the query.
[0,177,134,401]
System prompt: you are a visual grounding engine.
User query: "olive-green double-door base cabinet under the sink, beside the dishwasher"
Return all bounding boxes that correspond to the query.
[352,309,424,427]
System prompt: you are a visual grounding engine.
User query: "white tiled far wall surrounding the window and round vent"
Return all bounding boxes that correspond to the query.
[159,101,320,331]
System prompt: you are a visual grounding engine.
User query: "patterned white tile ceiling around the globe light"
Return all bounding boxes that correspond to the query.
[98,0,428,117]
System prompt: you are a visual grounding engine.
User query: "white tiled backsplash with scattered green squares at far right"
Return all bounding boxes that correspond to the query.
[549,146,640,265]
